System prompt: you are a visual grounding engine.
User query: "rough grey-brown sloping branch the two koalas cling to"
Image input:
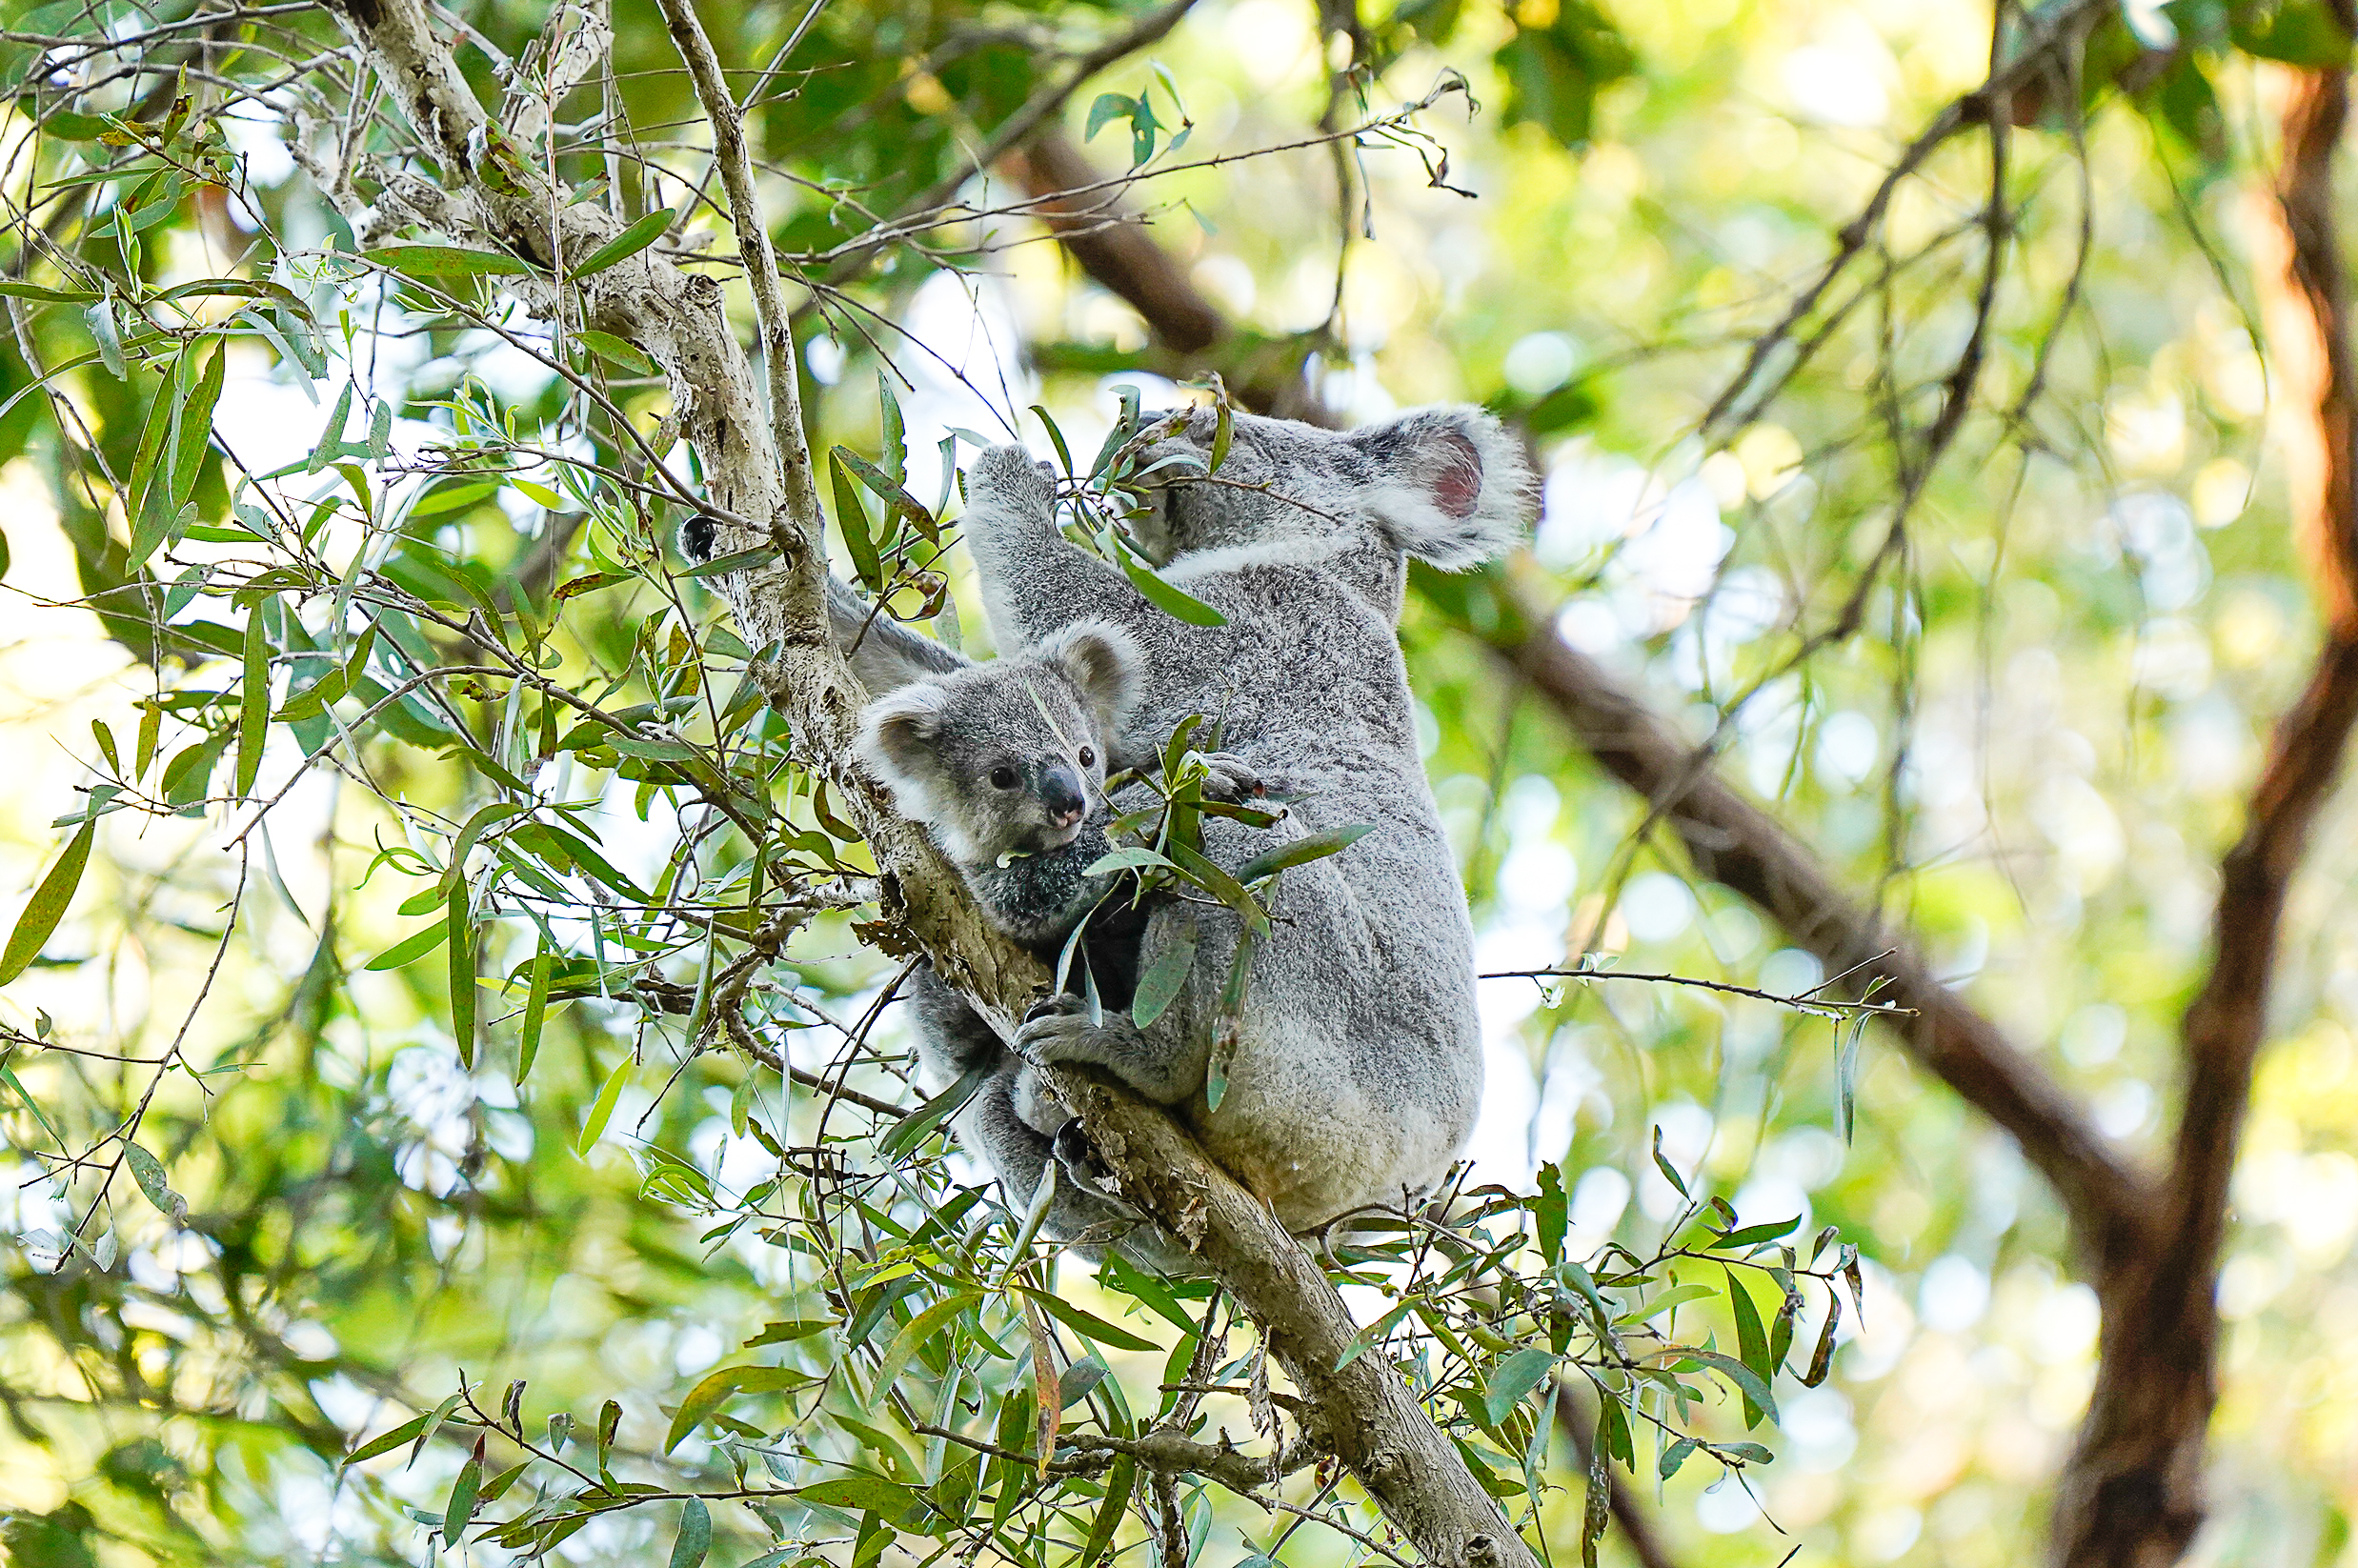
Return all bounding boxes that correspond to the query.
[337,0,1538,1568]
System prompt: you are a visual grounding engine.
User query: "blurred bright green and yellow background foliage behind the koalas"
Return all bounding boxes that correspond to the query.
[0,0,2358,1568]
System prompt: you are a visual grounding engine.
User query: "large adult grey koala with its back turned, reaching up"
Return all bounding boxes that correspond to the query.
[964,408,1530,1234]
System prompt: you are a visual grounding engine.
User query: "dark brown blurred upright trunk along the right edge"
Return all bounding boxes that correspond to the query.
[2054,69,2358,1568]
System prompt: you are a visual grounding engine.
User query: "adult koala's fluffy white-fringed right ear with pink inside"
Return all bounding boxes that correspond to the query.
[1351,403,1533,571]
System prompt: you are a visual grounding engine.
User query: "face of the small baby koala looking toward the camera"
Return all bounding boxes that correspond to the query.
[865,660,1106,865]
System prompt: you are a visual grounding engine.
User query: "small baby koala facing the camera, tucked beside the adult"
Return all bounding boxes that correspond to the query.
[828,577,1207,1274]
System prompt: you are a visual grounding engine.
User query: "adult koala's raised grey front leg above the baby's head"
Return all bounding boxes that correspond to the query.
[959,446,1143,651]
